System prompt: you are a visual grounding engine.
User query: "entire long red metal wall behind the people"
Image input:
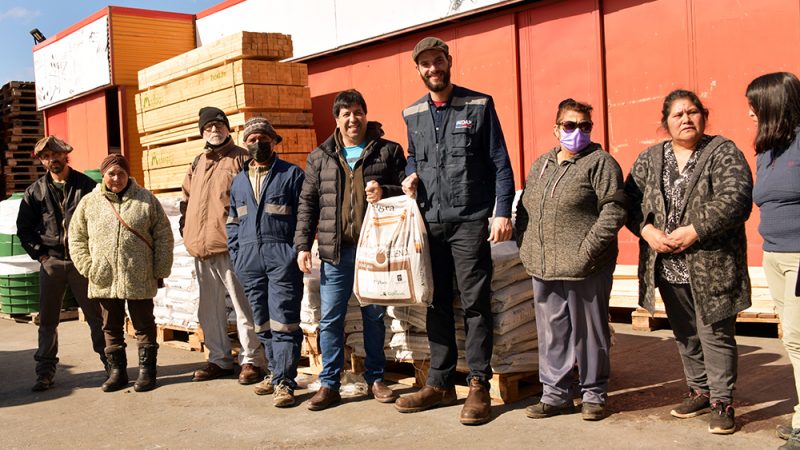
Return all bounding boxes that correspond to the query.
[308,0,800,266]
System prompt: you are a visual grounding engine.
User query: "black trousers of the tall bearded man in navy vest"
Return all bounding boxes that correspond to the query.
[426,219,493,387]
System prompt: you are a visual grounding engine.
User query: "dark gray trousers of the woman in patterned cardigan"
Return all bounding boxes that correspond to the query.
[658,281,738,403]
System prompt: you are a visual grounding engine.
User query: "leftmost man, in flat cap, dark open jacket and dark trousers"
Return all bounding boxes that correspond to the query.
[17,136,108,391]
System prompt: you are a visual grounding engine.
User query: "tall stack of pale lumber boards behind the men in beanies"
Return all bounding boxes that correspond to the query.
[136,31,316,192]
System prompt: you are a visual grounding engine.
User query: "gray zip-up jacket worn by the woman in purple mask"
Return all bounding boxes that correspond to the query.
[515,143,626,280]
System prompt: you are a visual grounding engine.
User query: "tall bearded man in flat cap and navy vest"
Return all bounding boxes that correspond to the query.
[395,37,514,425]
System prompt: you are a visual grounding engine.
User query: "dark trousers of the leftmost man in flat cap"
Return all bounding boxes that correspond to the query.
[33,256,105,376]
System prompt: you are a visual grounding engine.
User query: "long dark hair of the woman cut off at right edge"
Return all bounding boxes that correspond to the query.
[745,72,800,153]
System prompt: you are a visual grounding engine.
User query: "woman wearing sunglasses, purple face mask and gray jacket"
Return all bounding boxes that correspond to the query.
[515,98,626,420]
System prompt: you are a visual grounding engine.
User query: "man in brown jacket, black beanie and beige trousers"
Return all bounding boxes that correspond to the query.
[180,106,266,384]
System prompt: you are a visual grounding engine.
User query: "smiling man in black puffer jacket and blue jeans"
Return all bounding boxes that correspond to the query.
[294,90,406,411]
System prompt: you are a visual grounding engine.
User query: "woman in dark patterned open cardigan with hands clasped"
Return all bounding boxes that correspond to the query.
[625,90,753,434]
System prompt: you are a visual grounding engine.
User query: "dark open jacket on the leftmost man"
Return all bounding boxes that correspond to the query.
[17,168,97,260]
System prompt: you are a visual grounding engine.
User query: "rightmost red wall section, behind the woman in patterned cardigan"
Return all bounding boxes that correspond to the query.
[602,0,800,266]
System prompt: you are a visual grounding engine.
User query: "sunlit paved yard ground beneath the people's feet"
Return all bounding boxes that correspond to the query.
[0,320,797,449]
